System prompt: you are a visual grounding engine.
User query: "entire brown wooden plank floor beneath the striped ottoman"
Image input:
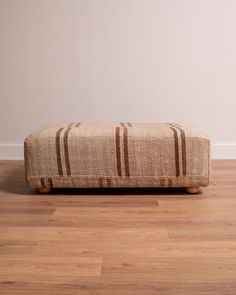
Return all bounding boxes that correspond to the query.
[0,161,236,295]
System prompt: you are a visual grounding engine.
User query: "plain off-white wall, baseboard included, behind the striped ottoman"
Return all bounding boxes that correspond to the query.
[0,0,236,158]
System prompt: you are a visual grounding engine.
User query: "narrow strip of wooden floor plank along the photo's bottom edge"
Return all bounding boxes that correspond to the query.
[0,284,236,295]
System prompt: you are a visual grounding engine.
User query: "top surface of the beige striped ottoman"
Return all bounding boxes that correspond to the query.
[27,122,209,140]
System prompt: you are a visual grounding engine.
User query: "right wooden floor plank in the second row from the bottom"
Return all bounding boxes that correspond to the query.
[102,257,236,283]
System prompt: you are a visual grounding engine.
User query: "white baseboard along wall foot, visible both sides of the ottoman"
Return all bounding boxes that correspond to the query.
[0,143,236,160]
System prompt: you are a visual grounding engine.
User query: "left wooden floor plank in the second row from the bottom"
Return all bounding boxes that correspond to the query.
[0,255,102,283]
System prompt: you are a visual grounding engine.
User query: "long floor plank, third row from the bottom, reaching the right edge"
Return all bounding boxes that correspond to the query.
[31,242,236,260]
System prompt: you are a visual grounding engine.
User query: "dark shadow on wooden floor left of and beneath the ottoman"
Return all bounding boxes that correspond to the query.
[0,161,197,197]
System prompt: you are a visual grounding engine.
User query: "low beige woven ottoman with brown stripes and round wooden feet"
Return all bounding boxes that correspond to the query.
[24,122,210,193]
